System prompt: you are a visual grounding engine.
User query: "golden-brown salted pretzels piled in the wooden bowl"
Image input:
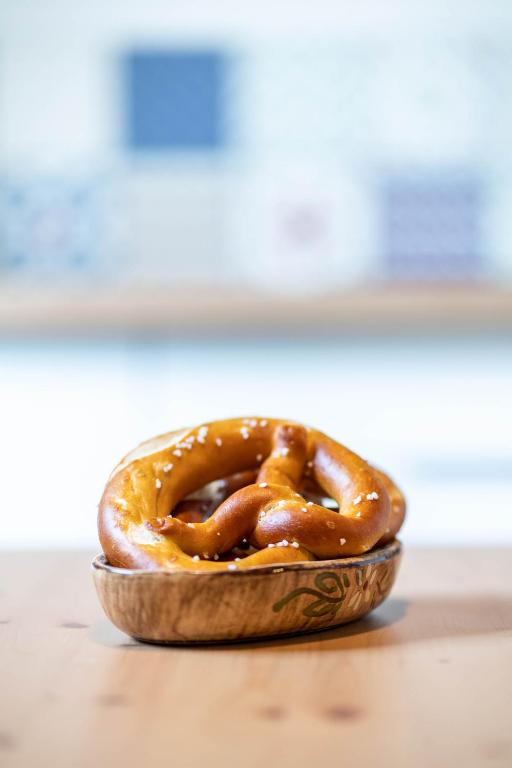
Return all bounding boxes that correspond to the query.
[98,418,405,570]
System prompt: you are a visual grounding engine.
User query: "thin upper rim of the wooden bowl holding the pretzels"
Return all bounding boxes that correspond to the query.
[91,539,402,578]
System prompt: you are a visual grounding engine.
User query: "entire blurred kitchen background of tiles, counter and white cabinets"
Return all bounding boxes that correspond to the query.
[0,0,512,548]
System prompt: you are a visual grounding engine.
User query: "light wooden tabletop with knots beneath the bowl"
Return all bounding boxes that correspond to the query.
[0,549,512,768]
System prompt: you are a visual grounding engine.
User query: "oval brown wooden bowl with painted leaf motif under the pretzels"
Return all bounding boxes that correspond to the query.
[92,539,401,644]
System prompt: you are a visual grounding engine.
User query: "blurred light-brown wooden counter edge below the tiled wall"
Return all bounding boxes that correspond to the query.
[0,284,512,335]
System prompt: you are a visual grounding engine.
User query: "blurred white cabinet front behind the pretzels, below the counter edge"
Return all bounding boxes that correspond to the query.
[0,339,512,548]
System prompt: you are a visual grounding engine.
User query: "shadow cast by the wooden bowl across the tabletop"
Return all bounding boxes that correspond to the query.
[91,594,512,652]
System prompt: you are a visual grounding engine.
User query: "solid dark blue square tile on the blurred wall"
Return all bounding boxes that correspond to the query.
[126,51,225,150]
